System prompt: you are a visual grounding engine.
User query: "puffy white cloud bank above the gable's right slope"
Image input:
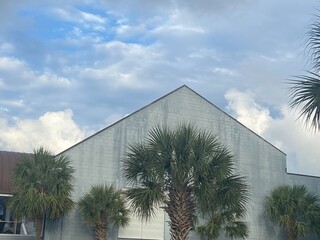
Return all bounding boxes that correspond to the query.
[225,89,320,176]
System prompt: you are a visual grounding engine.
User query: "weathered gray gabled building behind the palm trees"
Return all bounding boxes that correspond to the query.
[45,86,320,240]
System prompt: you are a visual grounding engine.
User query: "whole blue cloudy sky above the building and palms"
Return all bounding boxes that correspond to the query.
[0,0,320,175]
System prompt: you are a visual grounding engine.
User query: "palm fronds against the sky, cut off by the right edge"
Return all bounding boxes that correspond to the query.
[289,16,320,131]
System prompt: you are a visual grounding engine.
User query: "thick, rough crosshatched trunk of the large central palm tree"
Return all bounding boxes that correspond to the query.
[165,184,195,240]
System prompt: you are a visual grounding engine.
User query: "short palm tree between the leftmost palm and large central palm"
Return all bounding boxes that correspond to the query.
[78,185,129,240]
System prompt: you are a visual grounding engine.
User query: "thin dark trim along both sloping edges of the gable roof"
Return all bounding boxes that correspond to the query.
[58,84,286,155]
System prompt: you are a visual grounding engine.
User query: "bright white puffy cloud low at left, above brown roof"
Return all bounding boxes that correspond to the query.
[0,109,85,153]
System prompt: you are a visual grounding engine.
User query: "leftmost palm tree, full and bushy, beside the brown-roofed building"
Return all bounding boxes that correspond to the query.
[8,147,74,240]
